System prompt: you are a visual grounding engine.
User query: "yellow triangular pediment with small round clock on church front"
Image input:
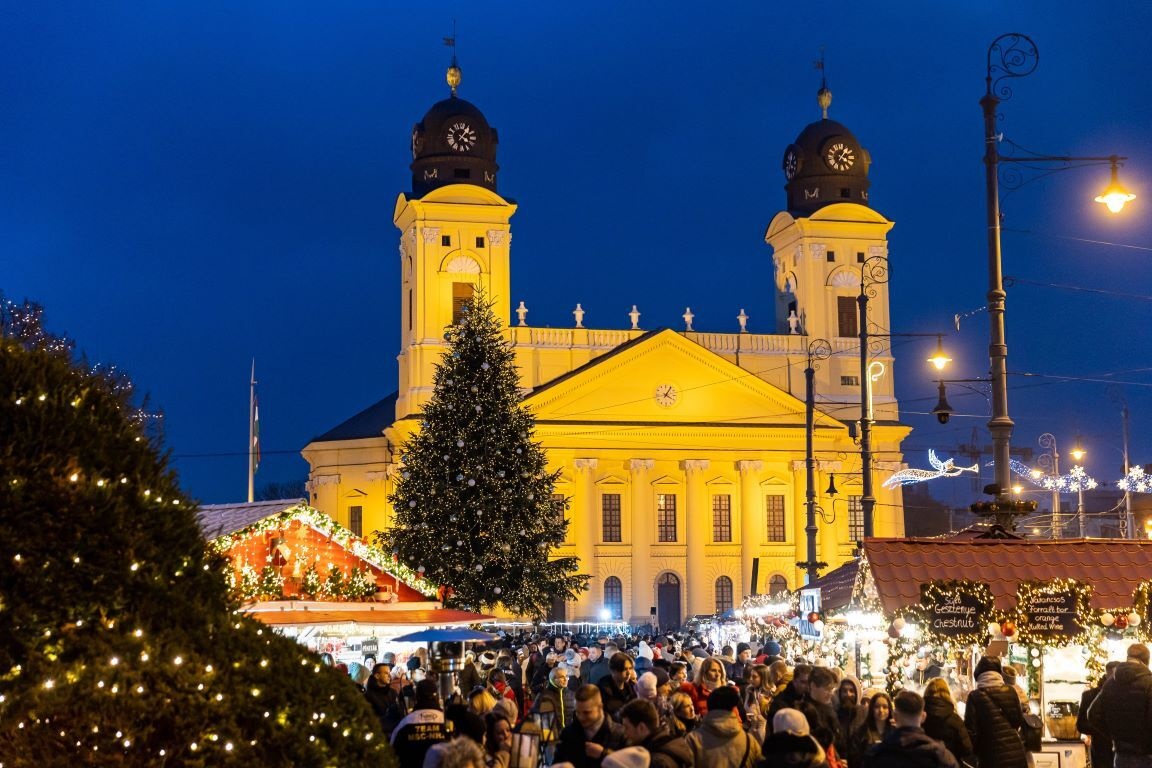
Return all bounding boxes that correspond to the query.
[524,329,828,427]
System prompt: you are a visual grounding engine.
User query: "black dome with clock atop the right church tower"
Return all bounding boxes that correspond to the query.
[783,86,872,215]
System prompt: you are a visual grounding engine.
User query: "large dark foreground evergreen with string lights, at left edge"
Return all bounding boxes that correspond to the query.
[0,296,395,768]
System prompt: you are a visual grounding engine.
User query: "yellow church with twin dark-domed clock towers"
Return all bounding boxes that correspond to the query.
[303,67,909,628]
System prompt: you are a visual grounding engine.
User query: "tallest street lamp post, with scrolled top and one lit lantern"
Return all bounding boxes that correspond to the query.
[980,32,1135,511]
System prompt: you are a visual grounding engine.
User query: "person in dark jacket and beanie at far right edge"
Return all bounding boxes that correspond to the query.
[1087,642,1152,768]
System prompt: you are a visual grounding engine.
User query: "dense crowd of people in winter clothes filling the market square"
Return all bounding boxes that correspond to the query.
[336,636,1152,768]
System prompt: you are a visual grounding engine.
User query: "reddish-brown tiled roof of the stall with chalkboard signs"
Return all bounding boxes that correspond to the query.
[864,539,1152,611]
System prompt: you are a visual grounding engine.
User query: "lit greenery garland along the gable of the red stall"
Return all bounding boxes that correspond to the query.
[211,504,437,600]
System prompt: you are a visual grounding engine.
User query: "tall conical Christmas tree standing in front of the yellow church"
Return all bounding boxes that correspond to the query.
[378,294,588,617]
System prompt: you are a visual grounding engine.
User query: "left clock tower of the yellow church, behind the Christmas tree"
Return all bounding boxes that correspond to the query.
[393,58,516,419]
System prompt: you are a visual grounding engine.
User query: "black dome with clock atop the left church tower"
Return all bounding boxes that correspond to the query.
[410,58,500,198]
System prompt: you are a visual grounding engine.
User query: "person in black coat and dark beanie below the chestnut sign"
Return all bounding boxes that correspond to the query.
[964,656,1028,768]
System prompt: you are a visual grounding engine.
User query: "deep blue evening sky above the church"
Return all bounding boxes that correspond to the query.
[9,0,1152,502]
